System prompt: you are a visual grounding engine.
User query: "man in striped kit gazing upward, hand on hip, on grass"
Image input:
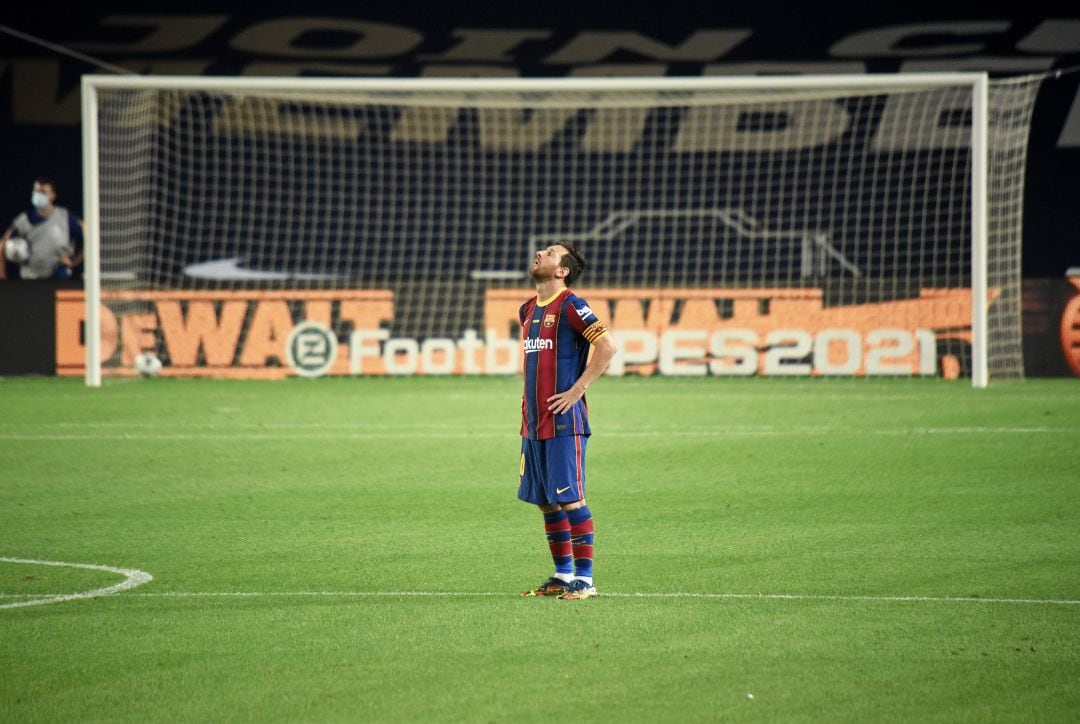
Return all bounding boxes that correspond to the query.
[517,243,617,601]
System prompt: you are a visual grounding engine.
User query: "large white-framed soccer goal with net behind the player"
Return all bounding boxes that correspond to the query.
[78,72,1041,387]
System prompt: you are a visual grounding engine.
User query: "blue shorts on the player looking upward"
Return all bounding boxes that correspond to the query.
[517,434,589,506]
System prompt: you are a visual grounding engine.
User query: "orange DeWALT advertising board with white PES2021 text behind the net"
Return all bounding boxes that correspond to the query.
[55,287,1010,379]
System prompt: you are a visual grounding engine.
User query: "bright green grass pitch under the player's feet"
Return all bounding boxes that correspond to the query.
[0,378,1080,722]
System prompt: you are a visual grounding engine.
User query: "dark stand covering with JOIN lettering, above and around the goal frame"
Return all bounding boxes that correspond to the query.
[0,0,1080,278]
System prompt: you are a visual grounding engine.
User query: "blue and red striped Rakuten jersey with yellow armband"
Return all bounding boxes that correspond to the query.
[518,290,607,440]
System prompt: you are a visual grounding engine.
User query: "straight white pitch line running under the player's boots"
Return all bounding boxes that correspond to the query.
[0,587,1080,607]
